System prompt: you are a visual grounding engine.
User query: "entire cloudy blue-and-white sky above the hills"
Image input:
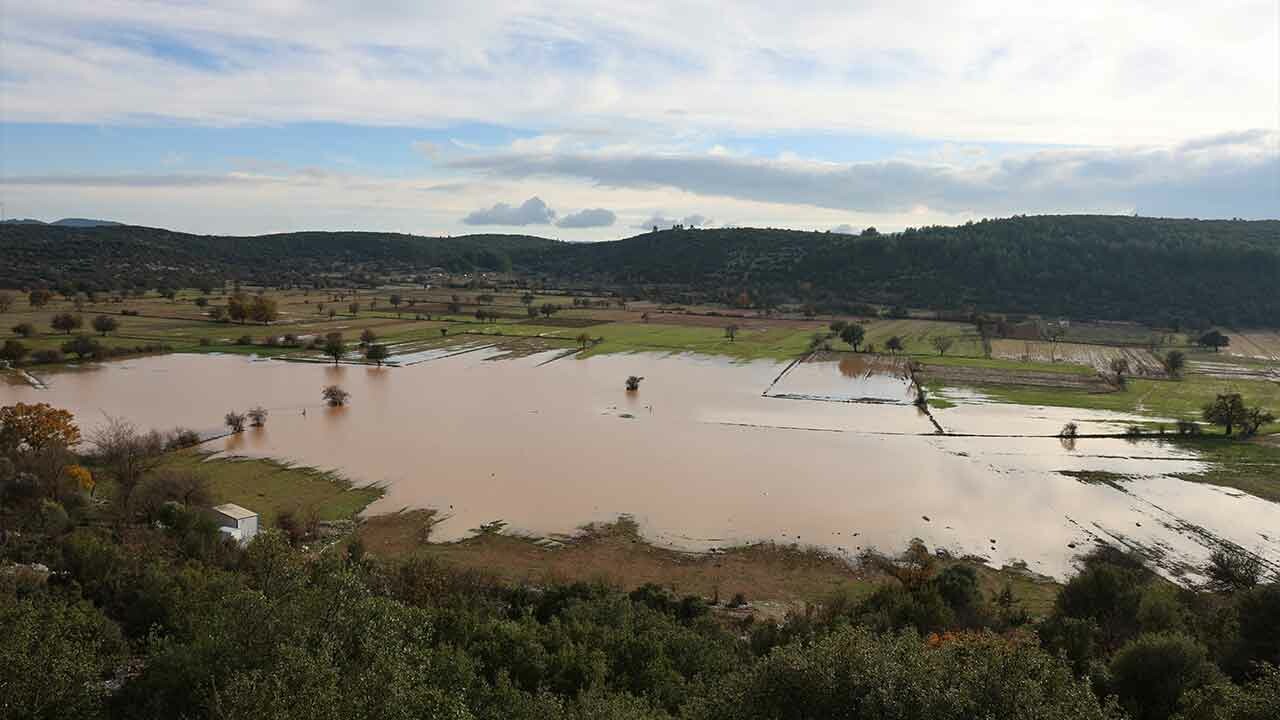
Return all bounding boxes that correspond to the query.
[0,0,1280,241]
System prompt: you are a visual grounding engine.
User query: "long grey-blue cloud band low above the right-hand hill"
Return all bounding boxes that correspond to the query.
[449,131,1280,219]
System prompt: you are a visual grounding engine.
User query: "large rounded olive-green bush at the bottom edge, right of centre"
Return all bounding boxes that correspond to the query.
[685,626,1107,720]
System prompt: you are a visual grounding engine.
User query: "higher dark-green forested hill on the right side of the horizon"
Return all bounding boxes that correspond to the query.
[563,215,1280,327]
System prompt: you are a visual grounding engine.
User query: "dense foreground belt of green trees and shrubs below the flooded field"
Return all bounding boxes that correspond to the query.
[0,404,1280,720]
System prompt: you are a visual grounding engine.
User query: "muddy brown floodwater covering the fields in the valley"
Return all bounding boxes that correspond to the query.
[0,352,1280,577]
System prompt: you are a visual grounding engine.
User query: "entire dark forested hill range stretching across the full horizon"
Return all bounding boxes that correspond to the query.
[0,215,1280,325]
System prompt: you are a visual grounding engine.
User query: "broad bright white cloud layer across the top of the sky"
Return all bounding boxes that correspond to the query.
[0,0,1280,145]
